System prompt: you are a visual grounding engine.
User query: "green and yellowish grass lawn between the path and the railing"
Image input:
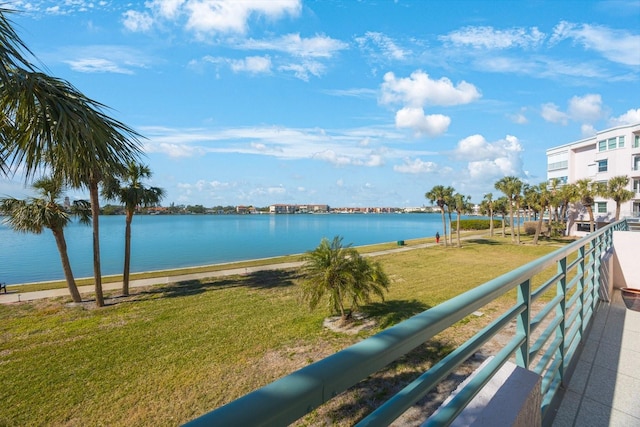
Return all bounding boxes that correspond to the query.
[0,238,568,426]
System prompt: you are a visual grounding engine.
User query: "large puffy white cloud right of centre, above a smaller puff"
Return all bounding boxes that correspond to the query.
[381,71,481,107]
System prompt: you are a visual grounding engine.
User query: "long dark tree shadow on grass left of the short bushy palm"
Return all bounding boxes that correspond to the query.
[127,269,299,298]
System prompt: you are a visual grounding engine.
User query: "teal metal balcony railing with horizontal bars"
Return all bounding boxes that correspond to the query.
[187,220,628,426]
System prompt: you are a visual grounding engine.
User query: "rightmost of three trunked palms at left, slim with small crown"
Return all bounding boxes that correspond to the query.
[102,162,164,296]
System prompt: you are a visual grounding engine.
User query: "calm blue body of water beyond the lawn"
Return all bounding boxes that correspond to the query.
[0,214,462,284]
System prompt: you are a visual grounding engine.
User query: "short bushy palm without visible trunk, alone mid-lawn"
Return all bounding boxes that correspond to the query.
[302,236,389,321]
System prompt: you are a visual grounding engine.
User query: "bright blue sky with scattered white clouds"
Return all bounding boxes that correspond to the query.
[0,0,640,207]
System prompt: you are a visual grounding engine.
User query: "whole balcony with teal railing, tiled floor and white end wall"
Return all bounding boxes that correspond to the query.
[188,220,640,426]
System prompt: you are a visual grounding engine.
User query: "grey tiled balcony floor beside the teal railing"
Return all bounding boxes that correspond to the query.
[552,290,640,427]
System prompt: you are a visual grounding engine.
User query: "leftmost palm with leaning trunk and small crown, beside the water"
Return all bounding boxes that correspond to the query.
[0,178,91,302]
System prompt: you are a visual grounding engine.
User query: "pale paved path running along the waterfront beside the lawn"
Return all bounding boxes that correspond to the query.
[0,241,440,304]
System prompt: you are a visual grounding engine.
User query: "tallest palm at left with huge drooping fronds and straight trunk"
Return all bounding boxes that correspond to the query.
[0,9,141,306]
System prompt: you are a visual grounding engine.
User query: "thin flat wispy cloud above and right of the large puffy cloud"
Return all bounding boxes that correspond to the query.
[439,27,546,49]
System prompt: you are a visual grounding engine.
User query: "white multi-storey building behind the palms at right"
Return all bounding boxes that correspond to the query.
[547,123,640,229]
